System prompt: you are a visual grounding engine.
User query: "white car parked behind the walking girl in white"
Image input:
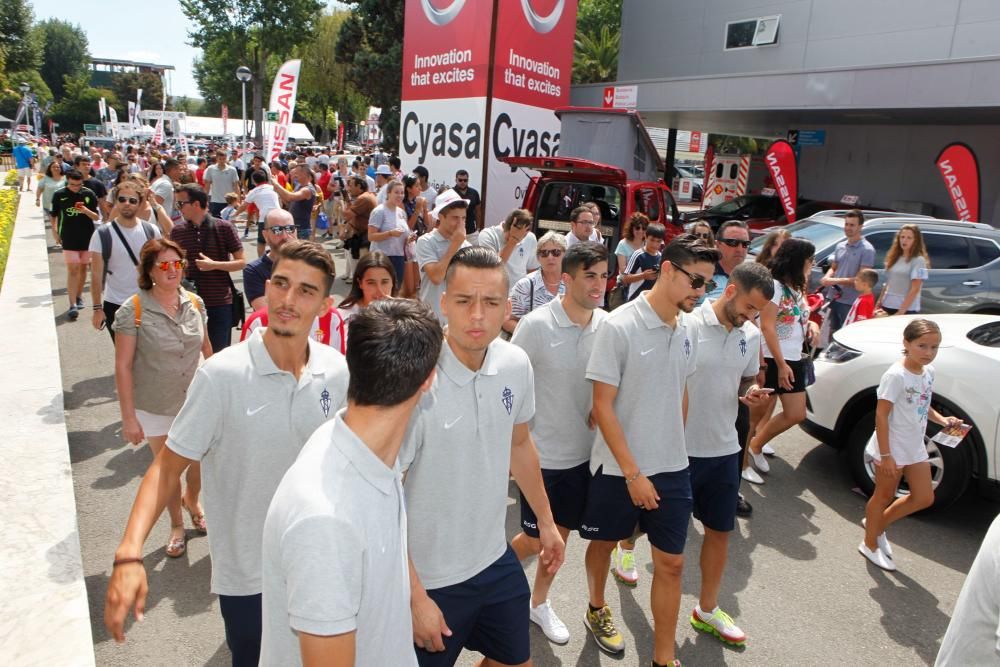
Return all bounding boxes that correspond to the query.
[801,315,1000,507]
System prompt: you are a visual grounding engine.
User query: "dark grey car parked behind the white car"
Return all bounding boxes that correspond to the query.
[749,214,1000,315]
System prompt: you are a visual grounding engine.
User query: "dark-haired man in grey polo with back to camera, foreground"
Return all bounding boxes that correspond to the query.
[261,299,441,667]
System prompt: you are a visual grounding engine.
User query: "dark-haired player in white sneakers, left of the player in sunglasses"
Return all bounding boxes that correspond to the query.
[512,243,608,644]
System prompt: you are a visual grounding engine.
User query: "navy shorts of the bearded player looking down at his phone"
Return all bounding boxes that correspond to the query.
[688,452,741,533]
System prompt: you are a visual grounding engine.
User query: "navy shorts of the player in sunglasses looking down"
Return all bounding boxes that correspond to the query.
[580,468,692,554]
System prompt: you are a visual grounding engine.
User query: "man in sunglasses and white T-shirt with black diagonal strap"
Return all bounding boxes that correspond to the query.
[90,180,160,343]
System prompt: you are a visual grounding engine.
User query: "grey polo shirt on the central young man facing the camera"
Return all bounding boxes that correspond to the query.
[399,339,535,589]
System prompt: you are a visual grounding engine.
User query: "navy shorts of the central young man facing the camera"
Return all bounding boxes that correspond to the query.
[415,545,531,667]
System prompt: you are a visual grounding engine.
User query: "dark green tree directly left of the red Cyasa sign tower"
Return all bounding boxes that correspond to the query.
[336,0,404,146]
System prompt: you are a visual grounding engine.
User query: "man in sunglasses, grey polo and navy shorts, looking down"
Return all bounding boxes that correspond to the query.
[580,234,735,665]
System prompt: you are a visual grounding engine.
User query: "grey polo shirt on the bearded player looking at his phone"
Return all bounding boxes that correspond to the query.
[684,301,760,457]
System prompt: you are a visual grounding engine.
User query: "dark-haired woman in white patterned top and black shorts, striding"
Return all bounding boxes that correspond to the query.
[743,238,819,484]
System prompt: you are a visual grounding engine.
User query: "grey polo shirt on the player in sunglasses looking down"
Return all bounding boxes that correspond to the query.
[587,292,697,477]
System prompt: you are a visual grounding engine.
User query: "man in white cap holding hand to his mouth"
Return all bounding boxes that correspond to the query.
[416,190,469,324]
